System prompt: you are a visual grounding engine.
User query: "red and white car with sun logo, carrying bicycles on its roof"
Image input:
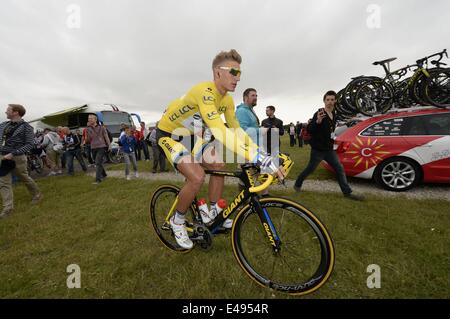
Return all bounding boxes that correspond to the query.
[324,108,450,191]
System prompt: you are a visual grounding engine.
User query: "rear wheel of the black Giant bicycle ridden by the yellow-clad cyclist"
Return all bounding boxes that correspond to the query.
[150,185,195,252]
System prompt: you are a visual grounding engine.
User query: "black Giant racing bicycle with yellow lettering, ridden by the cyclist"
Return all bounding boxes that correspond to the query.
[149,154,334,295]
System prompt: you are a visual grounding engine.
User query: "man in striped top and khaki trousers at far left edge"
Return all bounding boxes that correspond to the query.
[0,104,43,218]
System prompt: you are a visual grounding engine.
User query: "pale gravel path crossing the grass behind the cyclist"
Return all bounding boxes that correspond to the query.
[89,171,450,201]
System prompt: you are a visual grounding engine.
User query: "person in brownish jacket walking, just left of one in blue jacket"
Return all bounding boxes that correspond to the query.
[86,114,111,185]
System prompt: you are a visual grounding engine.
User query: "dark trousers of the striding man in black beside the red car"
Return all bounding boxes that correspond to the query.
[295,148,352,194]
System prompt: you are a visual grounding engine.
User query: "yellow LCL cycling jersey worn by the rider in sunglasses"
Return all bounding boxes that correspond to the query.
[158,82,258,161]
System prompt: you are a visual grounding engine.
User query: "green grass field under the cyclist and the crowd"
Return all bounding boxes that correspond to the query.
[0,175,450,298]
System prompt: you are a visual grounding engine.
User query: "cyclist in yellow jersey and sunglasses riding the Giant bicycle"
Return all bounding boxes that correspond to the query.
[156,50,284,249]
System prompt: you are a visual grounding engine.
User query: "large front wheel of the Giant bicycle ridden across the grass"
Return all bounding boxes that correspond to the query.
[231,198,334,295]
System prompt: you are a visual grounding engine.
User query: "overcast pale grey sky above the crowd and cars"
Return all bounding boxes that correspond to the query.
[0,0,450,123]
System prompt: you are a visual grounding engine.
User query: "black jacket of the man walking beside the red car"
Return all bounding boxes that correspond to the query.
[308,110,336,151]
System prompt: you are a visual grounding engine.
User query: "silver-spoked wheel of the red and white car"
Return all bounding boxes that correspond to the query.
[375,157,422,192]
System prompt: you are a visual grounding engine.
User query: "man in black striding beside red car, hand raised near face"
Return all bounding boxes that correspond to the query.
[294,91,363,200]
